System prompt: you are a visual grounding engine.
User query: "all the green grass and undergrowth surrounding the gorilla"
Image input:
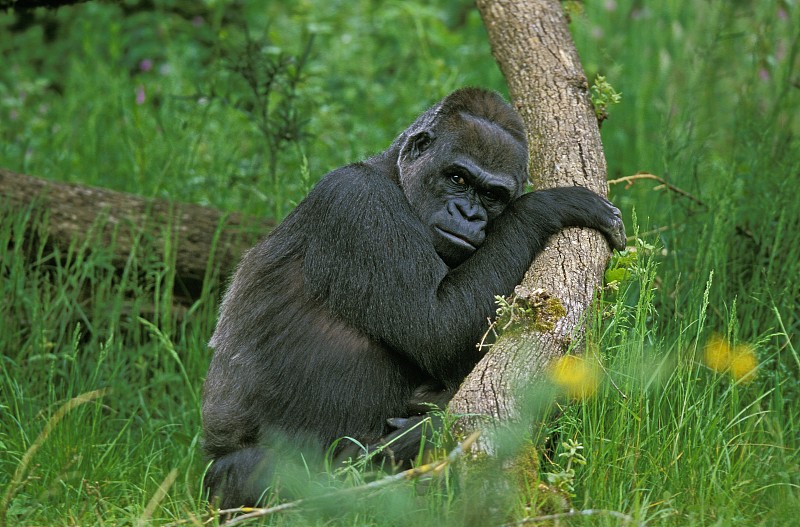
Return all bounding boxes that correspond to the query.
[0,0,800,526]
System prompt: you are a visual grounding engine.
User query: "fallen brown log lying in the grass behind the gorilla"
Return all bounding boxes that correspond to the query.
[0,169,272,301]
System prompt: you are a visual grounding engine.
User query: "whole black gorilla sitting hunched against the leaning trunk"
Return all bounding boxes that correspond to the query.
[203,88,625,508]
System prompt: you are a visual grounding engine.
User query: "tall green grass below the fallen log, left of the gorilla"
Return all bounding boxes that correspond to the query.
[0,208,213,525]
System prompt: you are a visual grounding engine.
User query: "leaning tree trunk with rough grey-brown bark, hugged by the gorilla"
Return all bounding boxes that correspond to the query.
[450,0,610,448]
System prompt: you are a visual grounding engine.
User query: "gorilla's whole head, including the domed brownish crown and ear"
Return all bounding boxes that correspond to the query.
[396,89,528,267]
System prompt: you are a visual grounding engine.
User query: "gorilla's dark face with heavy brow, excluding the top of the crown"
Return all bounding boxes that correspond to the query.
[400,120,527,268]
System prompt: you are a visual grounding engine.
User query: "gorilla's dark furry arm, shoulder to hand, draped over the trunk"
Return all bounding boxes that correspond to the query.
[303,163,622,389]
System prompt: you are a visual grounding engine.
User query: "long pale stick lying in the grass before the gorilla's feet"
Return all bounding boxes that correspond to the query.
[217,430,480,527]
